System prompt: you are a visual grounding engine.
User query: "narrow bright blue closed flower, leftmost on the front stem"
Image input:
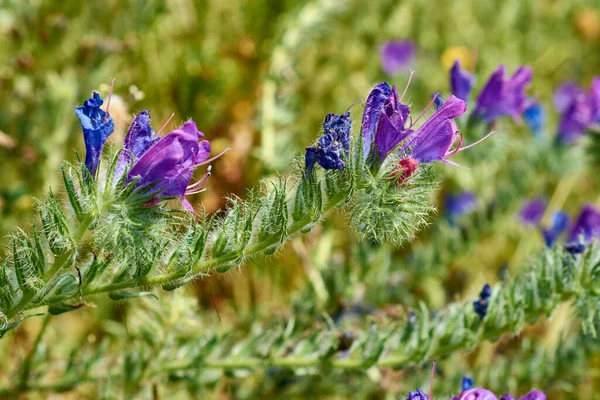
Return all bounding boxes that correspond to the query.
[75,92,115,176]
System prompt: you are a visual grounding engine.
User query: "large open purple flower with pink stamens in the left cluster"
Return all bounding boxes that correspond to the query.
[126,118,214,211]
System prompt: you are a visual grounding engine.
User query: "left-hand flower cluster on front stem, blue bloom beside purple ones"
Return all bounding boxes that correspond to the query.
[75,92,224,211]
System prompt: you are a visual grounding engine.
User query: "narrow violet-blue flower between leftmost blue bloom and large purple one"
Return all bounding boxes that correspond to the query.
[115,110,160,177]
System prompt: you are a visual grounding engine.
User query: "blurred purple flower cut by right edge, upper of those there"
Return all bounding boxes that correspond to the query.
[554,77,600,143]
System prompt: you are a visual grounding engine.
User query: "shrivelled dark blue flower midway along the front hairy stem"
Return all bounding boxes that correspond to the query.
[305,112,352,173]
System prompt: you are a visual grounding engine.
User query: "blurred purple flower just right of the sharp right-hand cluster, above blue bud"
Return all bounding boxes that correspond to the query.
[474,65,533,122]
